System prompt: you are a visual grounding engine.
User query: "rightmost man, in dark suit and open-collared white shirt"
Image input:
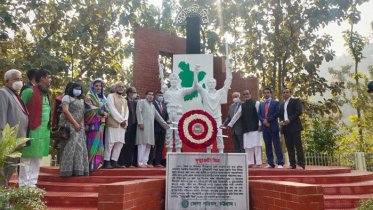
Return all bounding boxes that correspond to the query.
[280,88,306,169]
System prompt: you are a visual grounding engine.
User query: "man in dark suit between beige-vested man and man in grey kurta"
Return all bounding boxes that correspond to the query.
[118,87,137,168]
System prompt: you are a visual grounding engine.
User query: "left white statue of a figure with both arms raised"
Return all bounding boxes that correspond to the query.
[158,60,199,152]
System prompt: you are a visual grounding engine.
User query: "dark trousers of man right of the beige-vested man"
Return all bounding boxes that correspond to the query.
[118,126,137,167]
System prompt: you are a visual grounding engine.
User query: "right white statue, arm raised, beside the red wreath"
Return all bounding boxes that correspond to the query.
[196,61,232,153]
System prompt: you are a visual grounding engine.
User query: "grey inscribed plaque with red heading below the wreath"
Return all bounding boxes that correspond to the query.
[166,153,249,210]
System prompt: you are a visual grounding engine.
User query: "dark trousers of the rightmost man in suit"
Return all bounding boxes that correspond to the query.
[284,131,306,167]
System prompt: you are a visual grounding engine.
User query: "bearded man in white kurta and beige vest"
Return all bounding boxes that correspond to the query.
[103,83,128,168]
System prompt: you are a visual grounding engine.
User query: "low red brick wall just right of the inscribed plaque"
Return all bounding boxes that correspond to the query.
[249,180,325,210]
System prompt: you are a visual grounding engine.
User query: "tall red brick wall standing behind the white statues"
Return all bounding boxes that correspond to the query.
[133,27,259,152]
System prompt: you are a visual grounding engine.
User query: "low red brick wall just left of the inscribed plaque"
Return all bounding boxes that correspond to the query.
[98,179,166,210]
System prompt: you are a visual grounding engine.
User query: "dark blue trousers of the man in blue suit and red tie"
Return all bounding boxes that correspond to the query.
[263,130,284,167]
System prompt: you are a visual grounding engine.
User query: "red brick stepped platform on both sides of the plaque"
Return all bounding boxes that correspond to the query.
[10,165,373,210]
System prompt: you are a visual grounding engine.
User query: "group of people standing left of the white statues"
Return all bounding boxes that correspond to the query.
[0,69,172,187]
